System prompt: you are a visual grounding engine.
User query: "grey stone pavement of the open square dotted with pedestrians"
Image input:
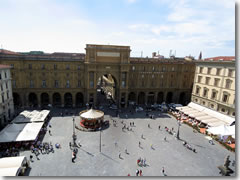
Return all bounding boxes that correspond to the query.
[21,107,235,176]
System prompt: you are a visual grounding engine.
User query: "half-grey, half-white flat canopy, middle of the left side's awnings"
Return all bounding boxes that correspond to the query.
[0,122,44,142]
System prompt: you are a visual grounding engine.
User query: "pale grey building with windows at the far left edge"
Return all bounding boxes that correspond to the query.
[0,64,14,129]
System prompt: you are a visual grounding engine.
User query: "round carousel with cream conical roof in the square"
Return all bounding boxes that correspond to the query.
[79,109,104,129]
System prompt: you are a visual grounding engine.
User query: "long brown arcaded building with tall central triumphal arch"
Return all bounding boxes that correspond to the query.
[0,44,195,107]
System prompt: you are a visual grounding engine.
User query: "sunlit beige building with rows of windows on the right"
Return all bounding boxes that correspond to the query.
[192,56,235,117]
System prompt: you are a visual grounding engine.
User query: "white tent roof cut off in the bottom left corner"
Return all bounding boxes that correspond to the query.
[0,156,27,176]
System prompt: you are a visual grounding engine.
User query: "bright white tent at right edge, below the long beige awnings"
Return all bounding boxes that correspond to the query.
[207,125,235,137]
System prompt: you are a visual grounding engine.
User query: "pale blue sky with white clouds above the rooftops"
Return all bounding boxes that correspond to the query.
[0,0,235,58]
